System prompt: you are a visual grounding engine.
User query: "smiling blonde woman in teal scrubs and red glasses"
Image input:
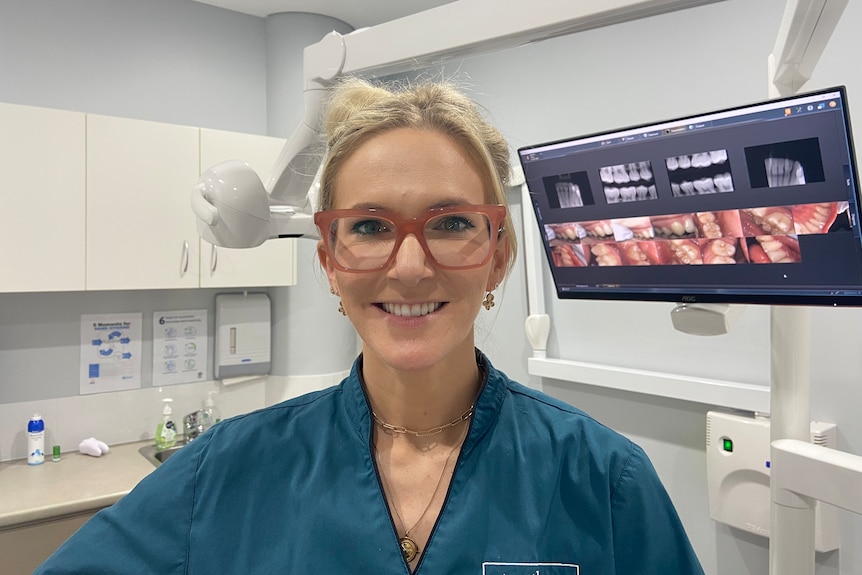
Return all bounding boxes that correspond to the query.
[39,80,702,575]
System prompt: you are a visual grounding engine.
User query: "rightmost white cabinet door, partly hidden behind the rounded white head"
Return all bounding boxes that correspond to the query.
[200,129,296,287]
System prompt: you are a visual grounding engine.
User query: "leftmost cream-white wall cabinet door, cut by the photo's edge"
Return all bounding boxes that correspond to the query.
[0,104,86,292]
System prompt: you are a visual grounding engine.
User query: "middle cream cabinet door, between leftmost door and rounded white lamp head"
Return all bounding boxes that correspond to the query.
[87,115,200,290]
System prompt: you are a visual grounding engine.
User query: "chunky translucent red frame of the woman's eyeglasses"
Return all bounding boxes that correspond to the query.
[314,204,506,273]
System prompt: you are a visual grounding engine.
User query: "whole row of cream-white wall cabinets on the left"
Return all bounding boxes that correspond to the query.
[0,104,296,293]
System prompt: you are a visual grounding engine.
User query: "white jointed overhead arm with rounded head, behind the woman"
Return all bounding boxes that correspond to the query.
[191,0,720,248]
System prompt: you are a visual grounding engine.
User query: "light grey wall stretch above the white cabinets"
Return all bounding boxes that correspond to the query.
[0,0,266,134]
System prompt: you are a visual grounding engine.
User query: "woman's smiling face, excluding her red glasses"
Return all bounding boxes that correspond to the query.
[318,128,507,371]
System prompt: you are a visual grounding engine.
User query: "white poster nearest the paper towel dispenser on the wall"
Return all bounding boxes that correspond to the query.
[153,309,207,386]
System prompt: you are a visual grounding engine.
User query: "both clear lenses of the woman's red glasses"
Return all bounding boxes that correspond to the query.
[330,211,492,270]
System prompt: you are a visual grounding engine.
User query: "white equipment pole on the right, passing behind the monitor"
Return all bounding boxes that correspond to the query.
[768,0,862,575]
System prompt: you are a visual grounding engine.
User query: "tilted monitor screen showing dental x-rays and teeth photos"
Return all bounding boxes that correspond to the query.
[518,87,862,305]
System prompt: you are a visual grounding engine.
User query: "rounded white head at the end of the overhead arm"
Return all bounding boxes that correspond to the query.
[191,160,270,248]
